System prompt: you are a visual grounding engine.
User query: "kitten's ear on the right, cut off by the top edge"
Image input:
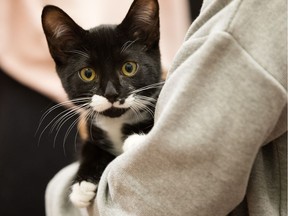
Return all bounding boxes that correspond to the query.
[118,0,160,49]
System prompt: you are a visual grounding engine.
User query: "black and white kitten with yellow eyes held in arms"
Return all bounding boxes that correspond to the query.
[42,0,163,207]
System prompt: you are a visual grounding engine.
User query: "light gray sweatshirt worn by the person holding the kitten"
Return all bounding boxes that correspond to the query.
[46,0,287,216]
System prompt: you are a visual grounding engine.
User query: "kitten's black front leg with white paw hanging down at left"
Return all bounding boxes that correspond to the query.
[70,142,115,208]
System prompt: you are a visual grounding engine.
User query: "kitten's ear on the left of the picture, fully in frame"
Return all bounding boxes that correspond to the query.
[42,5,86,65]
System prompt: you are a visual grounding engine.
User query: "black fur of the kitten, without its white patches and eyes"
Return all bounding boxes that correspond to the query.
[42,0,161,192]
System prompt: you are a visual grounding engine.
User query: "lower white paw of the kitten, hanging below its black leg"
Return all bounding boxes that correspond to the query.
[70,181,97,208]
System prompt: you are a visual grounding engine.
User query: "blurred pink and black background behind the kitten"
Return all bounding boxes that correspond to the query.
[0,0,202,216]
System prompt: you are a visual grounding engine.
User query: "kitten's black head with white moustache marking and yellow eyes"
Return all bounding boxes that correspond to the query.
[42,0,161,117]
